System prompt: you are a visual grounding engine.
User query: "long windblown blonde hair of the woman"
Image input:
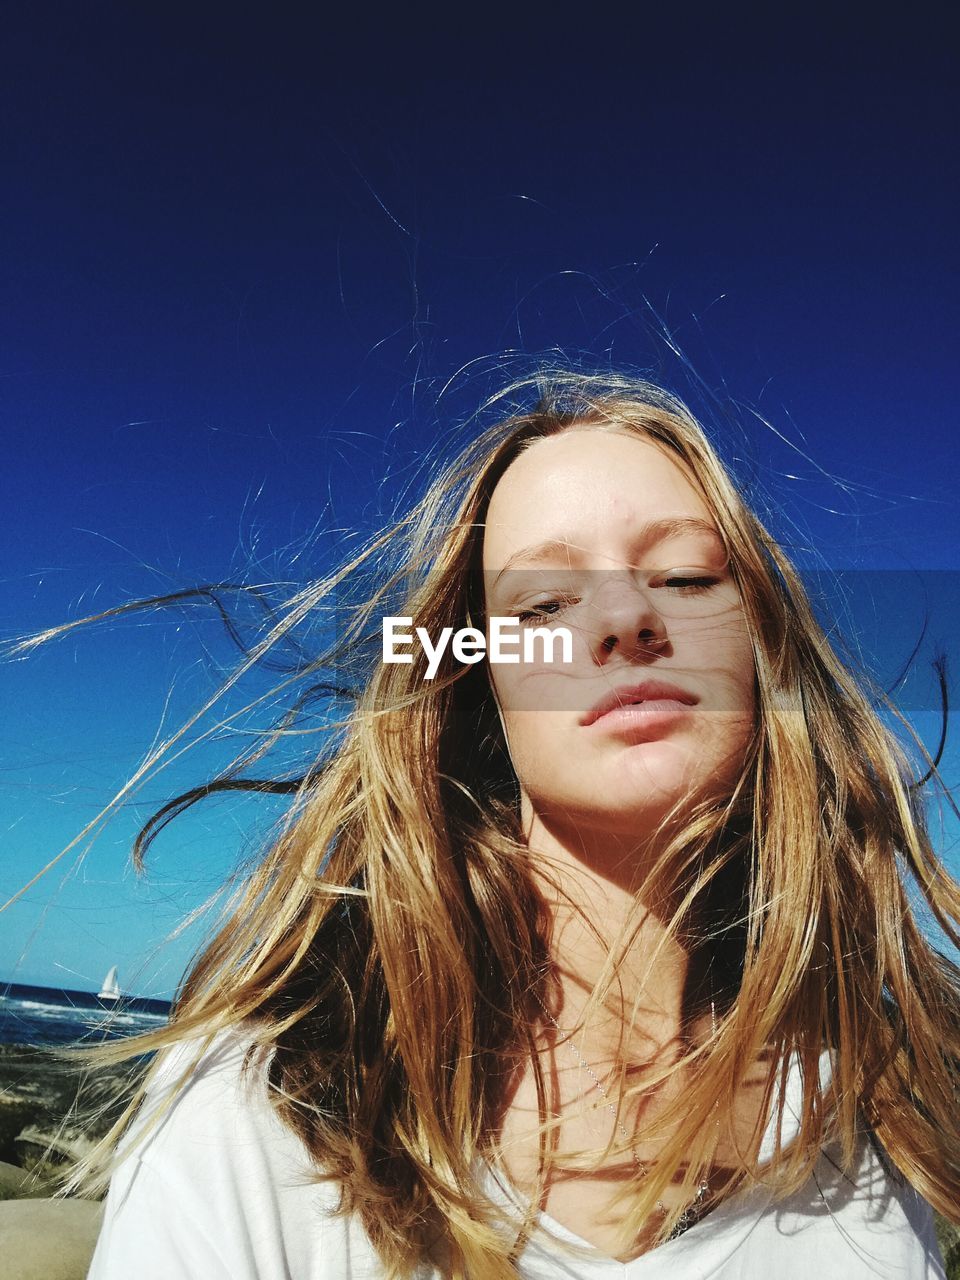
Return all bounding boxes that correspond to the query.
[9,367,960,1280]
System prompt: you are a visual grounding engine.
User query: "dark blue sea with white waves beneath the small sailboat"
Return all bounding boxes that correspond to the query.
[0,982,170,1044]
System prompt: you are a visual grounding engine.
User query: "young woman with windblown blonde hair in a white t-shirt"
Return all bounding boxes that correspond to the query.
[65,371,960,1280]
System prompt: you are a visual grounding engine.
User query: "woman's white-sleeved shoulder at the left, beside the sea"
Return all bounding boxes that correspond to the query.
[90,1030,378,1280]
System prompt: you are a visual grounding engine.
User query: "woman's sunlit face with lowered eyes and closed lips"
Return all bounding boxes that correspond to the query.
[483,426,755,844]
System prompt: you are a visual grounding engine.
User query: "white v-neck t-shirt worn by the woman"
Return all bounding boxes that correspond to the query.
[87,1033,943,1280]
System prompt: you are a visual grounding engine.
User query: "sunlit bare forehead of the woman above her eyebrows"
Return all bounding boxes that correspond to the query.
[484,428,716,567]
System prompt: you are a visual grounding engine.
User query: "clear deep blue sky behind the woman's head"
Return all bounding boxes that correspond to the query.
[0,3,960,995]
